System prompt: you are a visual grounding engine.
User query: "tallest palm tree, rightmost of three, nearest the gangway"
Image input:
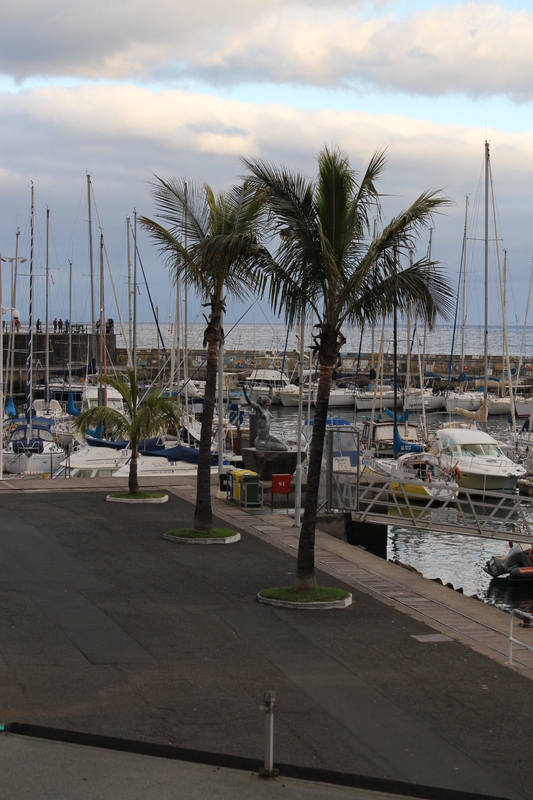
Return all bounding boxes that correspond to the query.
[243,147,451,590]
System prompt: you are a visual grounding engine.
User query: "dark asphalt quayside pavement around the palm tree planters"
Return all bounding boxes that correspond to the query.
[0,491,533,798]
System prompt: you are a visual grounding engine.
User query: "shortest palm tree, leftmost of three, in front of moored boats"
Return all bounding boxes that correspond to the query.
[75,369,180,494]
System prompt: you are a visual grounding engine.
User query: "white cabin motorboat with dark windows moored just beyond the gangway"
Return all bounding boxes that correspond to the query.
[430,423,526,491]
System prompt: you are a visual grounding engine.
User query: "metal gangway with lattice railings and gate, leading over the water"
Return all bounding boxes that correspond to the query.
[322,424,533,542]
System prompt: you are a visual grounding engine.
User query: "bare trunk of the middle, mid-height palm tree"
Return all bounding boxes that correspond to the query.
[194,337,218,533]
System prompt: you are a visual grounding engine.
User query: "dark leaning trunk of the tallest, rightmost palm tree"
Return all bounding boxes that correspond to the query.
[294,364,333,591]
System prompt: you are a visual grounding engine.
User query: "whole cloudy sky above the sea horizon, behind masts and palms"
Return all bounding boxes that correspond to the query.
[0,0,533,338]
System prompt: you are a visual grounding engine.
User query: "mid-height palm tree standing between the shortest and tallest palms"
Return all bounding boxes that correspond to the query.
[139,176,268,532]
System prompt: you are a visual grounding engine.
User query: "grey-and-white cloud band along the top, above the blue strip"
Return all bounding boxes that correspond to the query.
[0,0,533,102]
